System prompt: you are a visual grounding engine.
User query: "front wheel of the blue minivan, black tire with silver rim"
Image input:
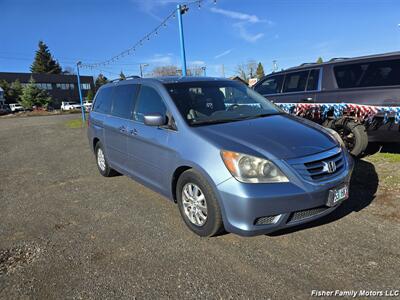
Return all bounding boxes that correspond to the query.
[176,169,224,237]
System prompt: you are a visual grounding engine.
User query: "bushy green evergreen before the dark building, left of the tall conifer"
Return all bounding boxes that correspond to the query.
[19,77,51,109]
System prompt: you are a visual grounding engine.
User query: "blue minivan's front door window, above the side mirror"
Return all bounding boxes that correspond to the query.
[134,85,167,122]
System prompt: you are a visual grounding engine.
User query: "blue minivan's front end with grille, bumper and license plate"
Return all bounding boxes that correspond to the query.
[217,147,353,235]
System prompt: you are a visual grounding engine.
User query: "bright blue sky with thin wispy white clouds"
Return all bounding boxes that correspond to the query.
[0,0,400,78]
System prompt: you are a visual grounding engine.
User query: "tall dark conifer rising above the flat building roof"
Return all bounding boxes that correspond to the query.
[31,41,62,74]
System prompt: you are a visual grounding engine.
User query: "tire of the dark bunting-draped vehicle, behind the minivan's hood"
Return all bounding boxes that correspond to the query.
[324,119,368,157]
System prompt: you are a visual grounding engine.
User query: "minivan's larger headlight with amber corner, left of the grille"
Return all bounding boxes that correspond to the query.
[221,151,289,183]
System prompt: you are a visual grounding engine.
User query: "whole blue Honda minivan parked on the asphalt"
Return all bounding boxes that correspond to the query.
[88,77,353,236]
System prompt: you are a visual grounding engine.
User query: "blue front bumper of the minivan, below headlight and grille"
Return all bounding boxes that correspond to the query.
[217,149,353,236]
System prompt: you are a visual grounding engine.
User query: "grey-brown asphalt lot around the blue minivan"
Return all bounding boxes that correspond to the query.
[0,115,400,299]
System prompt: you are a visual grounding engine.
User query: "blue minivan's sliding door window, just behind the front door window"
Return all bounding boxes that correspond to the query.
[112,84,138,119]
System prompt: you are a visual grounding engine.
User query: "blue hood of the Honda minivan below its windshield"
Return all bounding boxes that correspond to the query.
[195,114,337,159]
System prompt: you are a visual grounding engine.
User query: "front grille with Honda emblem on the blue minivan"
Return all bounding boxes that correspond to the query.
[291,149,345,181]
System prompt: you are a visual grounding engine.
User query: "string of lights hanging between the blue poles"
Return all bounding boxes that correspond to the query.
[80,0,217,70]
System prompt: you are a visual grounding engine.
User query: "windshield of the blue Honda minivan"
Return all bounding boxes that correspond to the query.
[165,80,283,126]
